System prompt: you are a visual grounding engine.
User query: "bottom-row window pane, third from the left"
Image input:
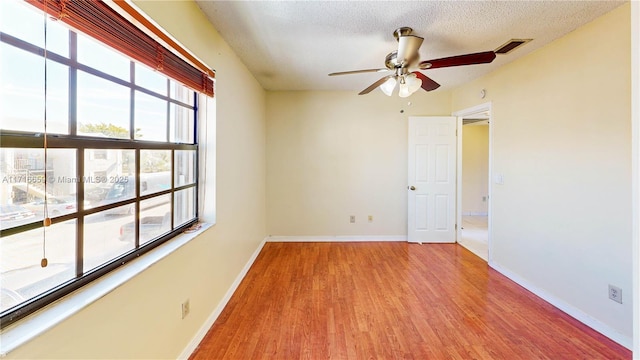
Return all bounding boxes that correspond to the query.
[134,194,171,245]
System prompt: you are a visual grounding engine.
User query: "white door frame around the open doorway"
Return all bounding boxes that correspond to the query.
[451,101,493,263]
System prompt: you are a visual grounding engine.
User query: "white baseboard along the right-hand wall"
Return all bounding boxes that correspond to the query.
[489,261,633,350]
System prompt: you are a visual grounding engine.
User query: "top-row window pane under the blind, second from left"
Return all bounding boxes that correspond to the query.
[78,34,131,80]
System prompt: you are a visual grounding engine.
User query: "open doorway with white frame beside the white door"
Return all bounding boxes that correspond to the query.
[454,103,492,261]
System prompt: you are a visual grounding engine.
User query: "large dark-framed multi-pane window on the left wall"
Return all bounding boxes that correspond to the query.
[0,0,212,326]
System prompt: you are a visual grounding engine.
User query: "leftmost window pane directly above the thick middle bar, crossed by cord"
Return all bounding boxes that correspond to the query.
[0,43,69,134]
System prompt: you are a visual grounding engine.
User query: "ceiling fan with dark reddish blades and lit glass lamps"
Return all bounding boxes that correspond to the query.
[329,27,496,97]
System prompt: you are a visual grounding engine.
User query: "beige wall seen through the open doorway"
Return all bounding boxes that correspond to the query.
[461,125,489,215]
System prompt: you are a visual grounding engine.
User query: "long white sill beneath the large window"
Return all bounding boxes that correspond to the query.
[0,223,213,358]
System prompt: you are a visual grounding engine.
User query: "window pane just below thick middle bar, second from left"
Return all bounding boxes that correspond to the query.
[83,149,136,214]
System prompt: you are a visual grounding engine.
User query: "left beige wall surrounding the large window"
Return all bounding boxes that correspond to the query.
[8,1,266,359]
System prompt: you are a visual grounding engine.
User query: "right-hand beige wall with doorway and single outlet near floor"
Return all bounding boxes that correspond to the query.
[453,3,632,346]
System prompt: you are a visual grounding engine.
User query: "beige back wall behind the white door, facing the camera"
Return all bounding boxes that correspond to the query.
[267,91,451,236]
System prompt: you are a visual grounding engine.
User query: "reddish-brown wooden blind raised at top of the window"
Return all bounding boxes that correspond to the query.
[25,0,215,96]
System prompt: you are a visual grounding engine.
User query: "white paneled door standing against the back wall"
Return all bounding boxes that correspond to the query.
[407,116,457,243]
